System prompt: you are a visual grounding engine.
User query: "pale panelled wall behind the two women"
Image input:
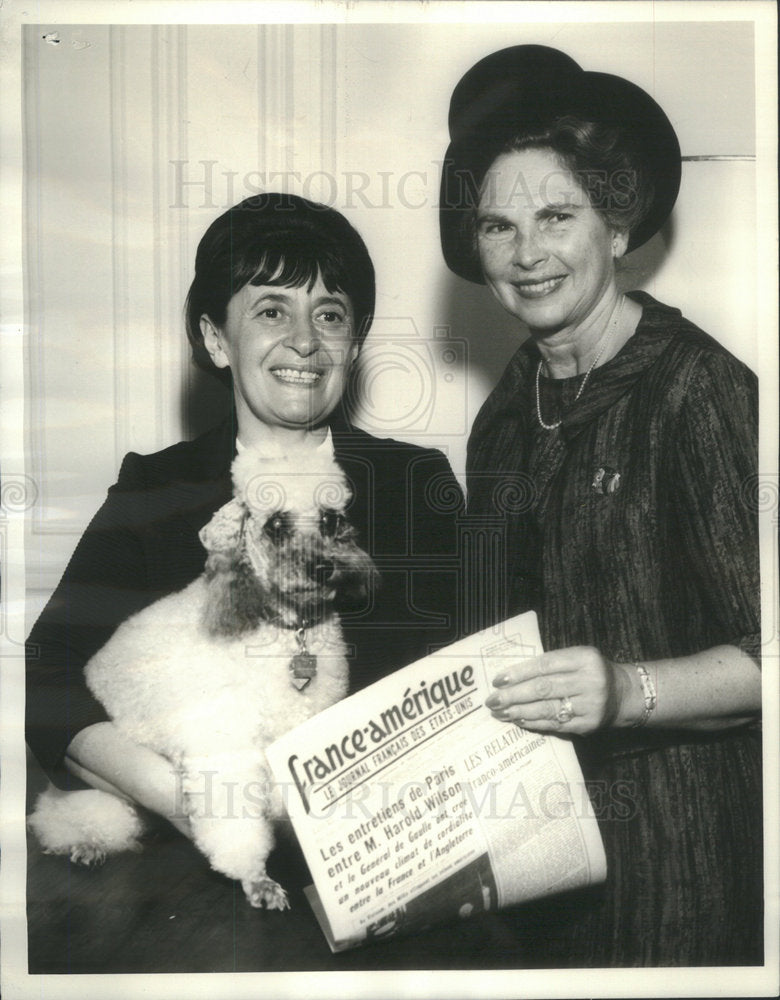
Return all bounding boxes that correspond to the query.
[23,22,757,614]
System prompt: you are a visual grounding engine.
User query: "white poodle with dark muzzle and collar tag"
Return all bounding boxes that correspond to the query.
[30,449,376,909]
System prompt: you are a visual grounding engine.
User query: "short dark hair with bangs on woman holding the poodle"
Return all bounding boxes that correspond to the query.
[184,192,376,381]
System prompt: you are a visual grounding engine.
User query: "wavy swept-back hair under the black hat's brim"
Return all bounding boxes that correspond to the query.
[490,116,654,233]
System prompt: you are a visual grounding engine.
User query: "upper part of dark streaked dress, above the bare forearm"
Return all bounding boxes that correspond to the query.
[467,292,760,676]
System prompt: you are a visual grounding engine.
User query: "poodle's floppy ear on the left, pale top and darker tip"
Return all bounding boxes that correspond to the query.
[199,499,263,637]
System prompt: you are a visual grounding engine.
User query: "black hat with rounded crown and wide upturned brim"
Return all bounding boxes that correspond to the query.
[439,45,680,284]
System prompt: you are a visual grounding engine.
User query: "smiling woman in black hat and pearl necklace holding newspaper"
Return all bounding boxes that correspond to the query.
[441,46,763,967]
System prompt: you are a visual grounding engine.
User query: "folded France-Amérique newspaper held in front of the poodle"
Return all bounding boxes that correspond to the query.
[267,612,606,951]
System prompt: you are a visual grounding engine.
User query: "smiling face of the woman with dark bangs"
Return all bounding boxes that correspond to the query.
[201,277,358,433]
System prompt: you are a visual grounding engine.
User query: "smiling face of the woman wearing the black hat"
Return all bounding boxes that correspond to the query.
[477,149,627,333]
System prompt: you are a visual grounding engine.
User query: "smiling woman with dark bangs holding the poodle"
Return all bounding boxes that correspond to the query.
[27,194,458,832]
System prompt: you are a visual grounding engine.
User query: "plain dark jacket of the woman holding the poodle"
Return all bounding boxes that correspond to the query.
[26,420,461,777]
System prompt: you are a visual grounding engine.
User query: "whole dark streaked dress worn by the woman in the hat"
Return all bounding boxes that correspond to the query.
[468,293,763,967]
